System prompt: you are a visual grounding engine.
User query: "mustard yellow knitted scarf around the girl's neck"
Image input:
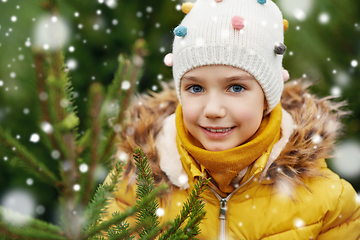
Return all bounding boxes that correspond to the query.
[175,103,282,193]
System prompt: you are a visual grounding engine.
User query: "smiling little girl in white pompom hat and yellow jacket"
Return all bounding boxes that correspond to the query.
[100,0,360,240]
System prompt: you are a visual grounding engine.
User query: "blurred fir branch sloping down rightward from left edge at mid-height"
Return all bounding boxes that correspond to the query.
[0,127,59,186]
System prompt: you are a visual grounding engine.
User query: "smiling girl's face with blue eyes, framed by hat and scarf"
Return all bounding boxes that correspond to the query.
[180,65,265,151]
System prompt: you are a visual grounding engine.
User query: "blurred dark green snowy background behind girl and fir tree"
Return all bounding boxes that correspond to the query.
[0,0,360,222]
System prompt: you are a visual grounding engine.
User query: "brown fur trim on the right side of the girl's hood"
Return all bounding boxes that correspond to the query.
[267,80,348,188]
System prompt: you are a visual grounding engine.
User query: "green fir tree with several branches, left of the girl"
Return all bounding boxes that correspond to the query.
[0,1,207,240]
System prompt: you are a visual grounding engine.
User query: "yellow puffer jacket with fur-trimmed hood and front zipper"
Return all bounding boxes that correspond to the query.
[104,82,360,240]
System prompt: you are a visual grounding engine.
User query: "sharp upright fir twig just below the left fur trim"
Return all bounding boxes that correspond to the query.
[133,147,160,238]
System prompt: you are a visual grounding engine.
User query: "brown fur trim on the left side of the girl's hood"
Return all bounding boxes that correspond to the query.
[117,84,179,184]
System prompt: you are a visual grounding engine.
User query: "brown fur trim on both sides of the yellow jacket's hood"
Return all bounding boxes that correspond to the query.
[114,80,348,187]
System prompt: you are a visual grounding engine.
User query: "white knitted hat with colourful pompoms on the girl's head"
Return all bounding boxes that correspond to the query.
[165,0,286,113]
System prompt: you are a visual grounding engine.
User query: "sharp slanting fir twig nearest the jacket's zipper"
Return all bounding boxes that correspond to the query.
[159,178,209,240]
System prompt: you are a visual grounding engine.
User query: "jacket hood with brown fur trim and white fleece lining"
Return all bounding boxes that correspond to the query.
[116,80,346,188]
